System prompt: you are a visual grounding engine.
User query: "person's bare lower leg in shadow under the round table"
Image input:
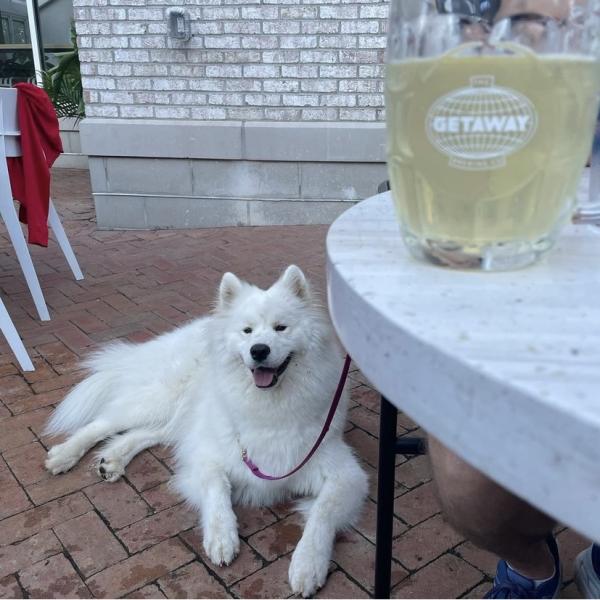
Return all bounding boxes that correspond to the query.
[429,437,555,580]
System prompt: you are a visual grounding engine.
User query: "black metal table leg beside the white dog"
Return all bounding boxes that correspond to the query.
[375,396,398,598]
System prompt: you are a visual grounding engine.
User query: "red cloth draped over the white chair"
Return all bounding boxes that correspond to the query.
[7,83,63,246]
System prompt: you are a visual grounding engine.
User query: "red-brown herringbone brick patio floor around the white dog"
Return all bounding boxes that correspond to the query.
[0,170,586,598]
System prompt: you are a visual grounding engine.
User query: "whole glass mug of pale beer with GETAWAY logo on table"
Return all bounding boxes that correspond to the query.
[386,0,600,271]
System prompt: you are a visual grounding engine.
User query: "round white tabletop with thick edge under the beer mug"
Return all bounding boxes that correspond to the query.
[327,182,600,541]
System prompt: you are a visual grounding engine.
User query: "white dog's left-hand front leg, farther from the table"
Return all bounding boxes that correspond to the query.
[178,465,240,566]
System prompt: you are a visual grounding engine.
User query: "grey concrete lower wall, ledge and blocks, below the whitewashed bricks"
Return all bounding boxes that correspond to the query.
[81,119,386,229]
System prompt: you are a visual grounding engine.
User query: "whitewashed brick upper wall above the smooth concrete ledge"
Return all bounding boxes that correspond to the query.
[74,0,388,121]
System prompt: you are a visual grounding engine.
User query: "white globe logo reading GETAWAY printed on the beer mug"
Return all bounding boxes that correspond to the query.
[426,75,538,170]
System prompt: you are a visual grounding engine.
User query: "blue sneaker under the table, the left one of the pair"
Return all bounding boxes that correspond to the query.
[485,536,562,598]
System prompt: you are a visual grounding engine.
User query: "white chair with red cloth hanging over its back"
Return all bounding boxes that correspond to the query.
[0,89,83,328]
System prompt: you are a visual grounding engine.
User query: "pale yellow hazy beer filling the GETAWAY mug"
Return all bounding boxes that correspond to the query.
[386,47,600,262]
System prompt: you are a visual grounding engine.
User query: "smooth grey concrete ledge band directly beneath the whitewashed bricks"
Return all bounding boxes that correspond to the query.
[80,118,385,163]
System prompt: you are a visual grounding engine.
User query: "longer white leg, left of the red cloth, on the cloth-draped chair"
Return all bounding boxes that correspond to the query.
[0,156,50,321]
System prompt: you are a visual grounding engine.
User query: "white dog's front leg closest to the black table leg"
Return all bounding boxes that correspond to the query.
[289,450,367,598]
